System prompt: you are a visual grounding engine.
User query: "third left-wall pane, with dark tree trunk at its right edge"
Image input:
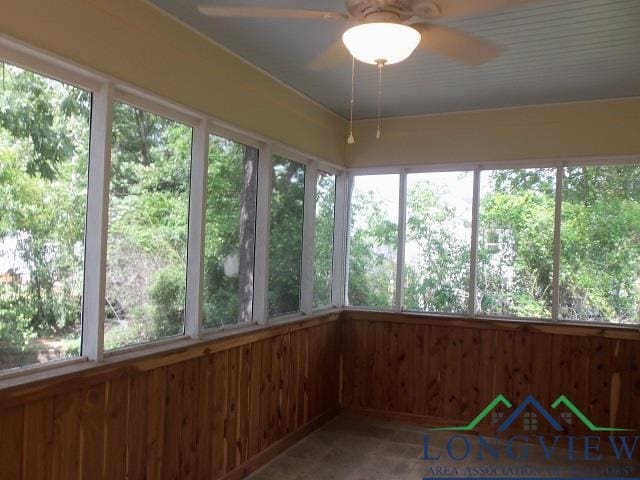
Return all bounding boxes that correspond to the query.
[203,135,258,328]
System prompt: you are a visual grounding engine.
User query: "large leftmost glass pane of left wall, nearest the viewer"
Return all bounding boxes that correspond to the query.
[0,63,91,370]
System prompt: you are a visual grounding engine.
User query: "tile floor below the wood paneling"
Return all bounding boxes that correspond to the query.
[248,414,640,480]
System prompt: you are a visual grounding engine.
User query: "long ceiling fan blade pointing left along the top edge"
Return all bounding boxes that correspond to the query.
[198,5,348,20]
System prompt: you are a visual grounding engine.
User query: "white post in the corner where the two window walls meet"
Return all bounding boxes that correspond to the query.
[331,172,349,307]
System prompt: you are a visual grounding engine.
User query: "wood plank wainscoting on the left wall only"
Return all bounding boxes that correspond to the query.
[0,314,340,480]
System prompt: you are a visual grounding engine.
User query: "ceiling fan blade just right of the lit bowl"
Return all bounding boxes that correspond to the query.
[411,23,500,66]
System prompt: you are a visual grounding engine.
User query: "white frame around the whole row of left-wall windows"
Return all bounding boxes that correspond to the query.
[0,34,347,381]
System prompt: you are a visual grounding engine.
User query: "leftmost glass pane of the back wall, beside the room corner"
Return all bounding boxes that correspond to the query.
[348,175,400,308]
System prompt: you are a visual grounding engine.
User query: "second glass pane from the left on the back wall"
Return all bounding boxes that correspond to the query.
[404,172,473,312]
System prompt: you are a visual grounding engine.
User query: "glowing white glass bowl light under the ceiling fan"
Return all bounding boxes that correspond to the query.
[342,22,421,65]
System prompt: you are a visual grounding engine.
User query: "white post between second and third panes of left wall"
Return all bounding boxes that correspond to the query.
[184,120,209,338]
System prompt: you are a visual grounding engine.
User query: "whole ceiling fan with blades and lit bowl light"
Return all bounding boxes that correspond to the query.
[198,0,540,70]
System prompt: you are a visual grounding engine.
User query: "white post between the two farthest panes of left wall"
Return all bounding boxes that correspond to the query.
[300,160,318,315]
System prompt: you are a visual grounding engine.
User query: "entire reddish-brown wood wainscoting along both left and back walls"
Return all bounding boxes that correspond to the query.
[5,311,640,480]
